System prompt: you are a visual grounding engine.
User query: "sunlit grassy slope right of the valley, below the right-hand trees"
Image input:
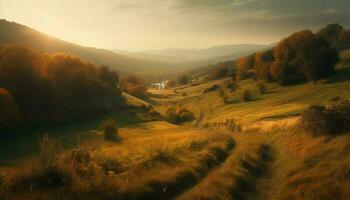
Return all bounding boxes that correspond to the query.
[147,51,350,200]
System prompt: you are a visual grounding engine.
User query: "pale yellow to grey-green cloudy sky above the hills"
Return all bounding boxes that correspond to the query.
[0,0,350,51]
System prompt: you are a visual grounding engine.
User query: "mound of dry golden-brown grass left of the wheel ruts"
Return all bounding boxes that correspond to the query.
[1,122,234,199]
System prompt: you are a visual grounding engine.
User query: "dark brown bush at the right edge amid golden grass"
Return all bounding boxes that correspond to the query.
[302,100,350,136]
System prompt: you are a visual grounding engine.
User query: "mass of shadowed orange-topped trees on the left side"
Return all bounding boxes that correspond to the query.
[0,45,124,130]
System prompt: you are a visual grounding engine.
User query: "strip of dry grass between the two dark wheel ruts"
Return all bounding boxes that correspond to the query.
[177,135,269,200]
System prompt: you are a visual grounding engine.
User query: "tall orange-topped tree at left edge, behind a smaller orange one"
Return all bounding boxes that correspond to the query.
[0,45,54,120]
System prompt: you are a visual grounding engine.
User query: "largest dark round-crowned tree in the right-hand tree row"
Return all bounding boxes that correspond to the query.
[271,30,338,85]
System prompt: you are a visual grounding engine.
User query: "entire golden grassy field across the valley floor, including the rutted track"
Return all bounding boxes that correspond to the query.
[0,52,350,200]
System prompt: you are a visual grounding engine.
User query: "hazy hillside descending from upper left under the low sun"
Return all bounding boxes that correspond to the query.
[0,20,193,75]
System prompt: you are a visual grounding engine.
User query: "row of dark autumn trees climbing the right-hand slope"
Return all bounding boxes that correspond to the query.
[209,24,350,85]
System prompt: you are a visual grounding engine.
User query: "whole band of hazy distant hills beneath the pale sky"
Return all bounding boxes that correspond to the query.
[0,19,268,78]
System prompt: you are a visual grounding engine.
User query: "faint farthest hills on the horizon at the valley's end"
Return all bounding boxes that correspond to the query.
[143,44,271,61]
